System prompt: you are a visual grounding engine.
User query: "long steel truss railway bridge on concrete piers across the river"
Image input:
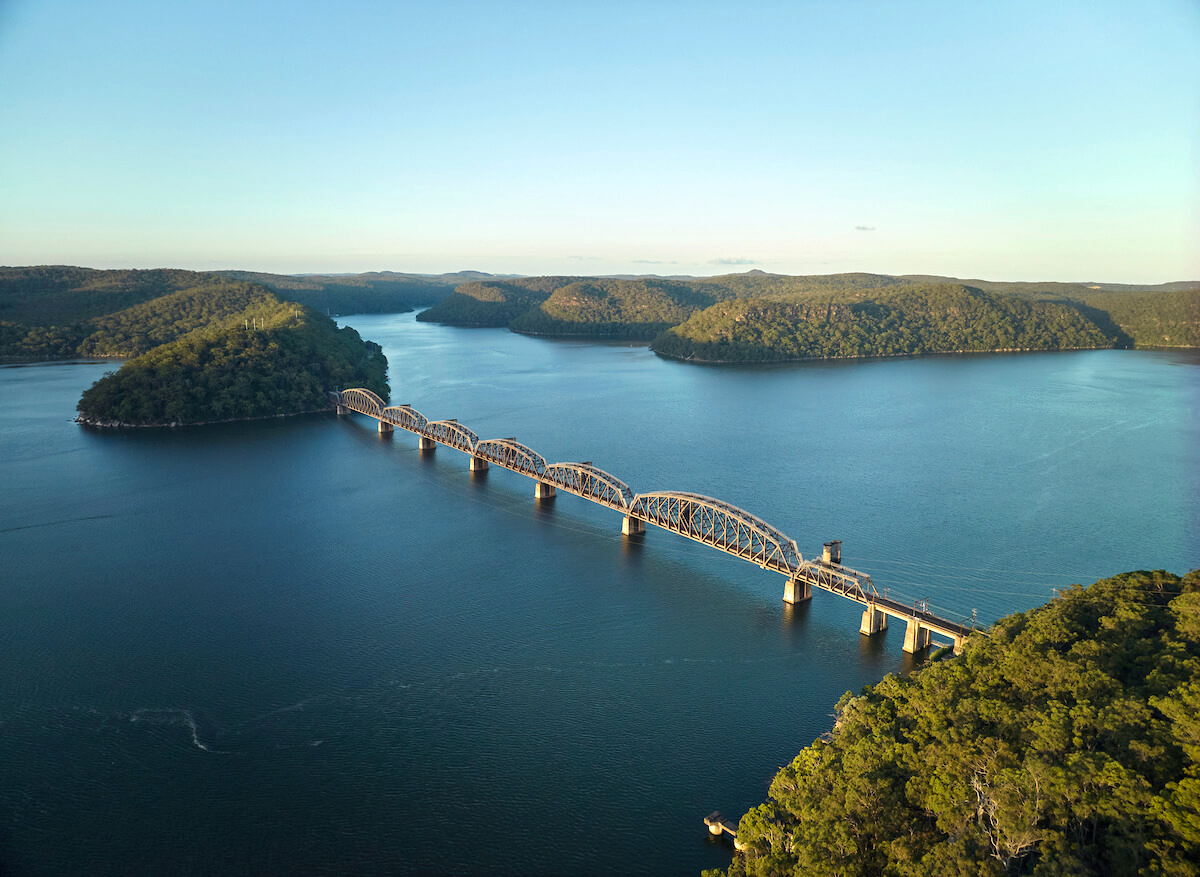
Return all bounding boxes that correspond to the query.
[330,389,974,654]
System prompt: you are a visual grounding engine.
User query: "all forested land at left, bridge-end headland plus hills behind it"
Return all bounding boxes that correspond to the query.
[0,268,388,426]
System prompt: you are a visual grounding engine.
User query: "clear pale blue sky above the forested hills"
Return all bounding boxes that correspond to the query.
[0,0,1200,283]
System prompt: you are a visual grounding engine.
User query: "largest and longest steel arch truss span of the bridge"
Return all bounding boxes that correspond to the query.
[629,492,804,576]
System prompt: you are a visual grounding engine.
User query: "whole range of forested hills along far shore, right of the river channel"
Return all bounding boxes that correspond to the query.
[408,271,1200,362]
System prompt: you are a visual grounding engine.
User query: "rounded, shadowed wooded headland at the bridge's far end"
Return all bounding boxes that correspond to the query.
[78,292,388,426]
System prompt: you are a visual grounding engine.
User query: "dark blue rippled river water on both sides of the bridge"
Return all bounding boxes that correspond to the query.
[0,314,1200,875]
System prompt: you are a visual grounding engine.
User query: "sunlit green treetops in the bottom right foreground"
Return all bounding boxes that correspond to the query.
[710,571,1200,877]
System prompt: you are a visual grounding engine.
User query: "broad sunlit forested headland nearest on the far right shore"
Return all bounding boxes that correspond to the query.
[653,284,1114,362]
